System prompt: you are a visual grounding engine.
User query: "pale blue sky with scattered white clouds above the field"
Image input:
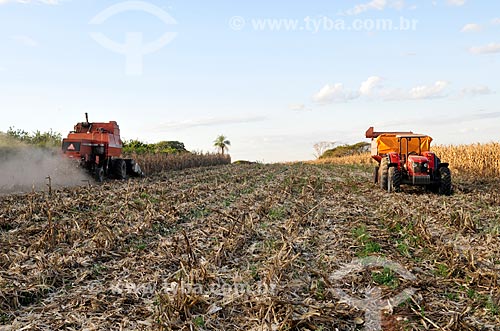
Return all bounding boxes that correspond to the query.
[0,0,500,162]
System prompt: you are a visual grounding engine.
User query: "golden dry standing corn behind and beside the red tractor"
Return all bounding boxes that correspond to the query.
[313,142,500,177]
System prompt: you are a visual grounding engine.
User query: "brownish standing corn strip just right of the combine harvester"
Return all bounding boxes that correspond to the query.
[128,153,231,175]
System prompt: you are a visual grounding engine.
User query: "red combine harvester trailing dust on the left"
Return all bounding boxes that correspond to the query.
[62,113,144,182]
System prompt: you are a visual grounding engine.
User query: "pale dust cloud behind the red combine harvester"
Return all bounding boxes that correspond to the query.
[0,139,91,195]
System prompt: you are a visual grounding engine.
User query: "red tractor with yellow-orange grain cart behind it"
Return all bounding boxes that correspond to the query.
[366,127,451,195]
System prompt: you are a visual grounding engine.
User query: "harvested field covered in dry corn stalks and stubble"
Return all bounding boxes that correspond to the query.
[0,164,500,331]
